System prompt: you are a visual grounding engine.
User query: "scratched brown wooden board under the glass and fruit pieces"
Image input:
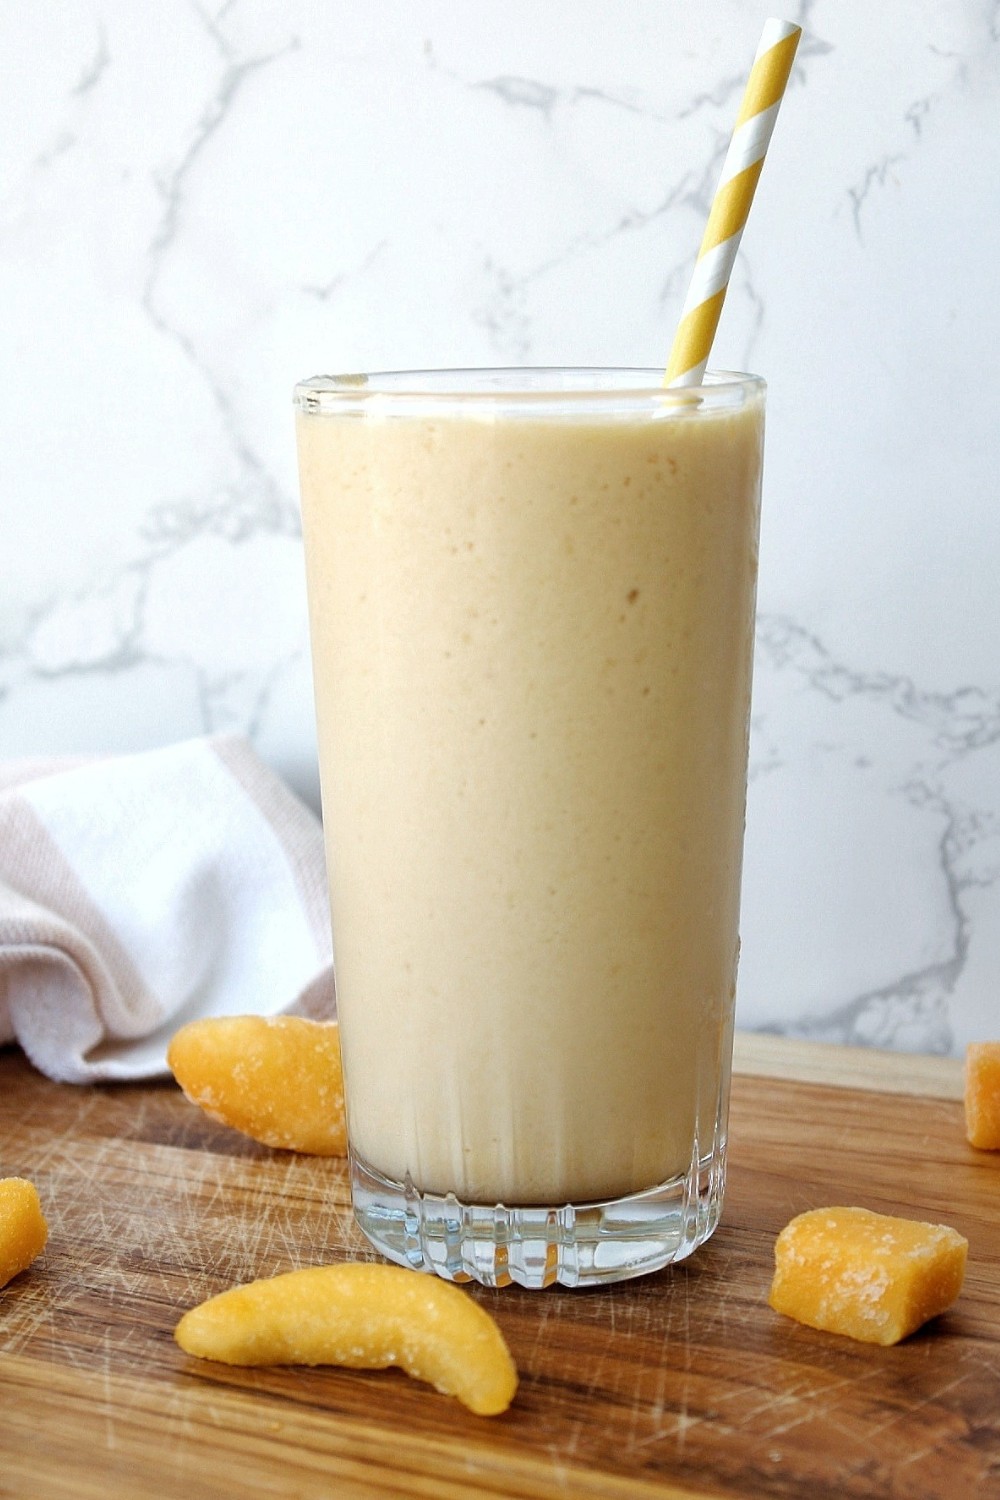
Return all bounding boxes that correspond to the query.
[0,1038,1000,1500]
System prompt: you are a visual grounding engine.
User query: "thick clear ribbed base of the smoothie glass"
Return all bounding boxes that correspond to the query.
[351,1140,726,1289]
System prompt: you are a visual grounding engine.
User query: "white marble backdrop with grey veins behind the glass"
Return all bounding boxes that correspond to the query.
[0,0,1000,1052]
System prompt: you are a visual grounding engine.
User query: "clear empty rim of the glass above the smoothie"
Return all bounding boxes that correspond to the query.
[292,365,766,414]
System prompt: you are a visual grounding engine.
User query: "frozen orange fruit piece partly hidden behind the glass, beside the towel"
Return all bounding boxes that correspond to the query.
[166,1016,348,1157]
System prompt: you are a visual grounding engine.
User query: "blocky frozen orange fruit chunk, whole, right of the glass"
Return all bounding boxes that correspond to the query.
[768,1208,969,1344]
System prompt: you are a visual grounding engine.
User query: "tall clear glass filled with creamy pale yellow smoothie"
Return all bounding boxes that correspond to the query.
[295,369,765,1287]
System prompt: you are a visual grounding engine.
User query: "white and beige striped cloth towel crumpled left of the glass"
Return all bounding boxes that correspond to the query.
[0,738,334,1083]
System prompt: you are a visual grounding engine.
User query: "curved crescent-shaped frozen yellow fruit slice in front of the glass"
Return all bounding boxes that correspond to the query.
[174,1262,517,1416]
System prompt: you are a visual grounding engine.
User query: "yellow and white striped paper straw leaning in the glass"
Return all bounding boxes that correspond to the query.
[664,20,802,386]
